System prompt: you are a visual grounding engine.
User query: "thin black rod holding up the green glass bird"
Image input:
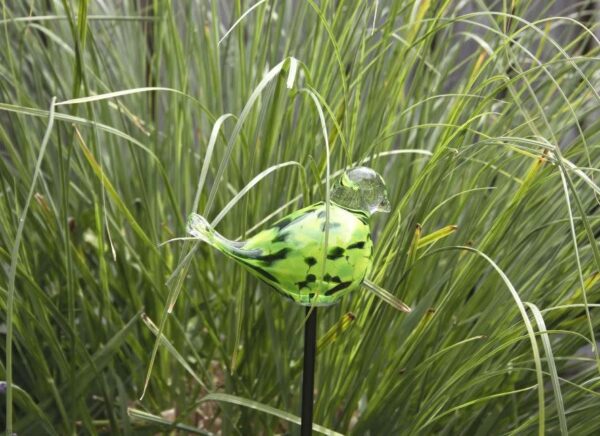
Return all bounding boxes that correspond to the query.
[300,306,317,436]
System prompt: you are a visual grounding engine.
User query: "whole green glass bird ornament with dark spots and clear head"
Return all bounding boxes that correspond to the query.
[187,167,411,312]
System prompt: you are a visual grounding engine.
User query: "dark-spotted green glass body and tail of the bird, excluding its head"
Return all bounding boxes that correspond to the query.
[188,202,373,306]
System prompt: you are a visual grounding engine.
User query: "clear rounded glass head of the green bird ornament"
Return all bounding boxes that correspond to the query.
[331,167,391,215]
